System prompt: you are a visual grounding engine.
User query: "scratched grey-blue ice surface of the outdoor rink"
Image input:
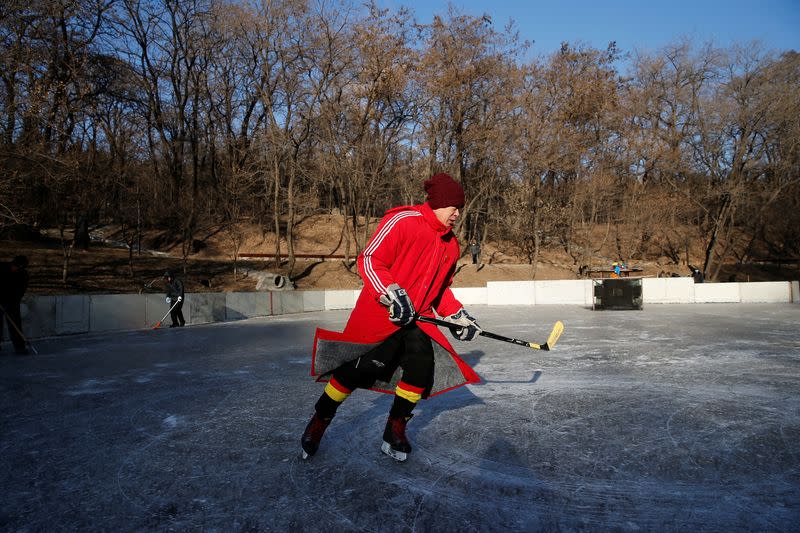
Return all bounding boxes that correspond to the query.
[0,304,800,532]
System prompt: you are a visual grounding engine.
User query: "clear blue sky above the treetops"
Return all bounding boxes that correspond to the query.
[377,0,800,56]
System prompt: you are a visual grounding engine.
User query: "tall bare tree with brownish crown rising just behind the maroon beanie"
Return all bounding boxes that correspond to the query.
[415,7,525,245]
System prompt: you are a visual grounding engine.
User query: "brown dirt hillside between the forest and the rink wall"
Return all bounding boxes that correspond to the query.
[0,215,797,294]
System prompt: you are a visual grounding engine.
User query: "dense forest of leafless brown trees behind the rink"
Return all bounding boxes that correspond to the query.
[0,0,800,280]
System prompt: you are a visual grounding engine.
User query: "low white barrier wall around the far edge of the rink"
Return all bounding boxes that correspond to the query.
[14,278,800,339]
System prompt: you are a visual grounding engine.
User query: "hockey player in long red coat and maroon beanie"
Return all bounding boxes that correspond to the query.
[301,173,481,461]
